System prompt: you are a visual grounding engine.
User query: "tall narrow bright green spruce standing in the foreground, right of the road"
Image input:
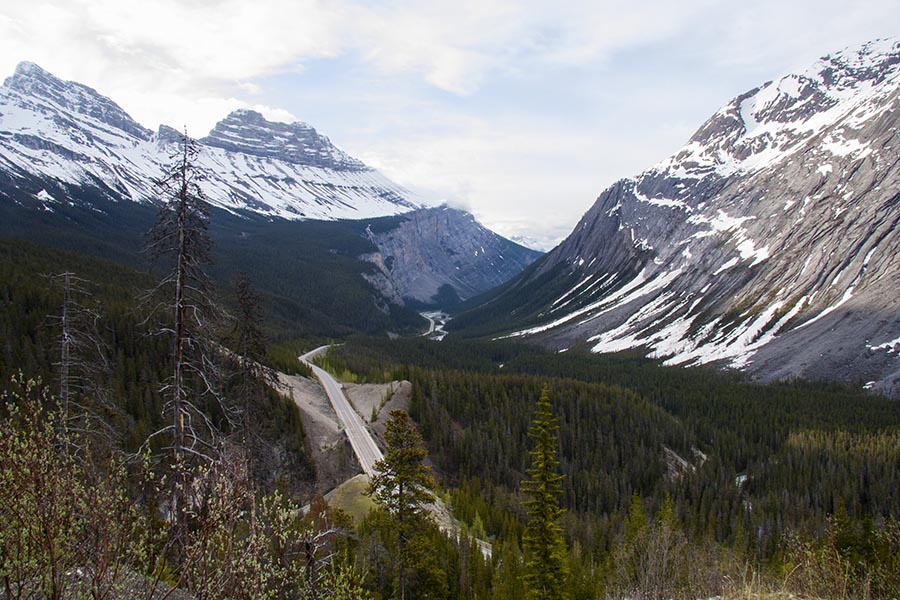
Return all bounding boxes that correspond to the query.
[522,385,567,600]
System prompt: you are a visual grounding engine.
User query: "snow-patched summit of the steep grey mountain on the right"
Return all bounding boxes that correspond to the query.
[658,39,900,178]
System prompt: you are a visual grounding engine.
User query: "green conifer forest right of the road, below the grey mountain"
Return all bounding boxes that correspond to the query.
[329,339,900,597]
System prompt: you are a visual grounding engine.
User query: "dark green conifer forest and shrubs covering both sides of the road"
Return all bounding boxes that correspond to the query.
[0,227,900,598]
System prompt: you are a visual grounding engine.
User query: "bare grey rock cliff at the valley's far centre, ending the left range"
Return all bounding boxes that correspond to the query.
[358,207,540,304]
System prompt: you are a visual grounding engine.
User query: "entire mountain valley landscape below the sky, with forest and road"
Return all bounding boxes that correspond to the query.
[0,35,900,600]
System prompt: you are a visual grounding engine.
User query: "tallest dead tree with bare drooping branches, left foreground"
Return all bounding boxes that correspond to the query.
[144,132,235,546]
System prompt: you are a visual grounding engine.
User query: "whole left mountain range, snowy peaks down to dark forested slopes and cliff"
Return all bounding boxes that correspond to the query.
[0,63,540,328]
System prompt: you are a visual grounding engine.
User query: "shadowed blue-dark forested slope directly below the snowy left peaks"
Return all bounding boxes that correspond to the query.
[0,193,425,339]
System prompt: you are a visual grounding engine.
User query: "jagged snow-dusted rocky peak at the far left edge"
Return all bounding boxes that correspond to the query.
[3,61,151,140]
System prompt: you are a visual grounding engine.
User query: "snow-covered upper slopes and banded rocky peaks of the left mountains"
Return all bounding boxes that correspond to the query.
[0,63,422,219]
